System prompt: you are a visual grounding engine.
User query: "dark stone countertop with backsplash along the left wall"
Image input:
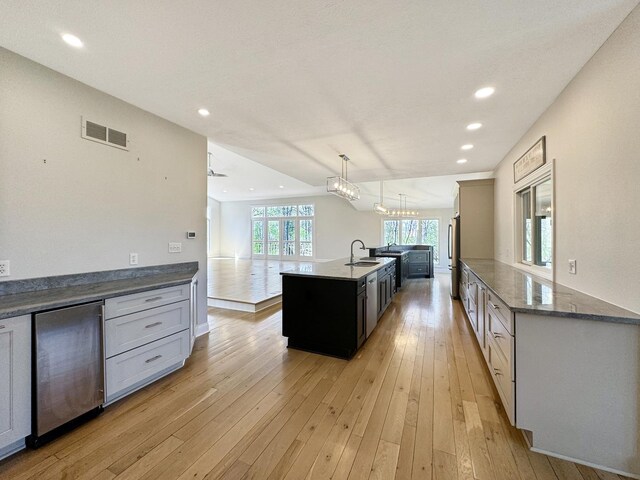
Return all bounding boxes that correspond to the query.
[0,262,198,319]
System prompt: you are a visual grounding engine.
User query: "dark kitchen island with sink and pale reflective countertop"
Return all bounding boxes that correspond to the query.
[280,258,395,359]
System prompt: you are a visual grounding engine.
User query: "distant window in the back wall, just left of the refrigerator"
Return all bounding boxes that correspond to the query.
[382,218,440,263]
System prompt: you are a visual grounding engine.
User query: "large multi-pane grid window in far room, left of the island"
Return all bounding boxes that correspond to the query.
[251,205,314,260]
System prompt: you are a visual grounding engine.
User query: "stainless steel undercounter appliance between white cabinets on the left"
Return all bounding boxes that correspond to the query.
[27,302,104,447]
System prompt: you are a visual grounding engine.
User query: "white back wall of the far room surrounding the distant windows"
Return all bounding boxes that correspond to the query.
[220,195,453,268]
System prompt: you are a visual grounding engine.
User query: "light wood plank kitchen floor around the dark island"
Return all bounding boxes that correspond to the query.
[0,275,632,480]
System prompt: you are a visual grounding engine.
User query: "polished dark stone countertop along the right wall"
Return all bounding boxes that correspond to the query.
[461,258,640,325]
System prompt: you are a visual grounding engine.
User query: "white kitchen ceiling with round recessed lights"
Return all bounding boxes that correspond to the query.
[0,0,638,207]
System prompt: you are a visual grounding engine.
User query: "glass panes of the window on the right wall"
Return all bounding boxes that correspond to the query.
[516,176,553,269]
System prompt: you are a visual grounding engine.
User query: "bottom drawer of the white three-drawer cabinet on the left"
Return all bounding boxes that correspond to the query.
[106,330,189,399]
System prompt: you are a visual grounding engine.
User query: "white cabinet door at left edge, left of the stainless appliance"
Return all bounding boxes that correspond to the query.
[0,315,31,458]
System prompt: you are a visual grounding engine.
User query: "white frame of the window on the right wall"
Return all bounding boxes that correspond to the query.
[513,160,557,281]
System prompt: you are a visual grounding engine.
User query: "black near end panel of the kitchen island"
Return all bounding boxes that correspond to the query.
[282,275,367,358]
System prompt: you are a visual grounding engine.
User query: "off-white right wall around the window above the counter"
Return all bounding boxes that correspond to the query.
[495,7,640,312]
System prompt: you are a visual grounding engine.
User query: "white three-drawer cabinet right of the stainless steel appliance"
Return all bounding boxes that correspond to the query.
[105,283,194,404]
